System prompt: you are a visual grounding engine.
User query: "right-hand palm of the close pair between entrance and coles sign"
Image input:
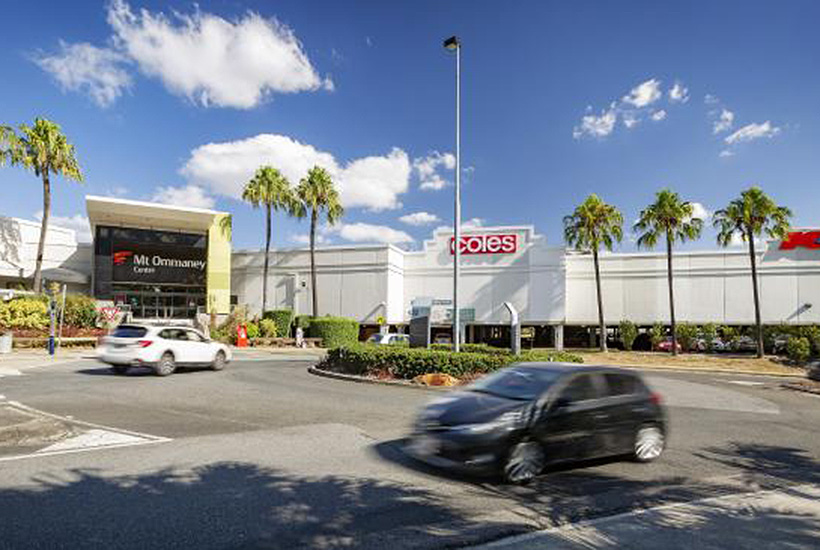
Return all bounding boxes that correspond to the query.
[293,166,344,317]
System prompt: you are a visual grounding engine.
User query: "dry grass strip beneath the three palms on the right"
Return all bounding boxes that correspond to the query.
[556,349,806,375]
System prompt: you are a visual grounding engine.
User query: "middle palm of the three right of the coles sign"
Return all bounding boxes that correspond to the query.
[634,189,703,355]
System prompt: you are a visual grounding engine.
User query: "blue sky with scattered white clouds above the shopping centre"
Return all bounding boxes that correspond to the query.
[0,0,820,250]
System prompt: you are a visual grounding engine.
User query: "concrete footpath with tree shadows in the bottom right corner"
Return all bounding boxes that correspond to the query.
[473,485,820,550]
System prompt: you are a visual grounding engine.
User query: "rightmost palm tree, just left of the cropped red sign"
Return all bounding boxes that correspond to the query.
[714,186,792,357]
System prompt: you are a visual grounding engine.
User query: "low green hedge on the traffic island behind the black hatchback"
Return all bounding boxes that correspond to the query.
[322,344,583,379]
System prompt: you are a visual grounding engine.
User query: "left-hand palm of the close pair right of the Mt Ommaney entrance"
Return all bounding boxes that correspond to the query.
[242,166,296,314]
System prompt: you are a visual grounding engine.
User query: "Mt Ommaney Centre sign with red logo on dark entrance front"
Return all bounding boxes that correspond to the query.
[111,243,208,285]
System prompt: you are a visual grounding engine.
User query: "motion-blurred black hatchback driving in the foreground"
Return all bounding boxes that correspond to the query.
[406,363,667,483]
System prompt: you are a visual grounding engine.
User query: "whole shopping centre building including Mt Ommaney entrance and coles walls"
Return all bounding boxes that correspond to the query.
[0,196,820,345]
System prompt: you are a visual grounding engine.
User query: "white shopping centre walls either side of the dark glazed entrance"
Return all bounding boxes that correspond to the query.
[0,203,820,345]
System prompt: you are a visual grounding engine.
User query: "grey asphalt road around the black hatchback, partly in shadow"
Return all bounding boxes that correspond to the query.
[0,358,820,549]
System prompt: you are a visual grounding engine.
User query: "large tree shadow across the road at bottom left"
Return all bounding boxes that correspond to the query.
[0,462,522,549]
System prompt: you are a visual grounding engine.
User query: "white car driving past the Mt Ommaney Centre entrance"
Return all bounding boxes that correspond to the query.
[97,324,231,376]
